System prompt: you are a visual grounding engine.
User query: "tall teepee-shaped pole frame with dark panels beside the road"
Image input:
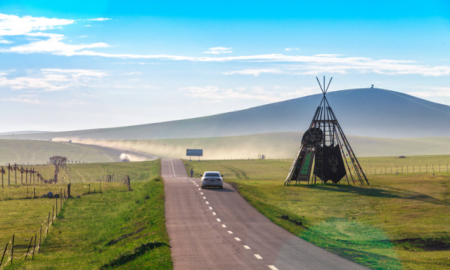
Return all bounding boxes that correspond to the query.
[284,77,369,185]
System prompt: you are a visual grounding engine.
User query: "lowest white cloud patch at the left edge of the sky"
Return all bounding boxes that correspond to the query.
[0,69,108,92]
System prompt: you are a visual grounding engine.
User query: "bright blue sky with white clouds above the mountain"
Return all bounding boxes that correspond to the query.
[0,0,450,132]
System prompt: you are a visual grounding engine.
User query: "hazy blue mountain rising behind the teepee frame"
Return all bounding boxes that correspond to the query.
[0,88,450,140]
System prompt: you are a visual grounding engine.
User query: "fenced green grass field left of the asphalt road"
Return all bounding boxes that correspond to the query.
[0,160,172,269]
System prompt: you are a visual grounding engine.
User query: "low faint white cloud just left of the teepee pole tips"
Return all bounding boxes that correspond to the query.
[179,86,315,102]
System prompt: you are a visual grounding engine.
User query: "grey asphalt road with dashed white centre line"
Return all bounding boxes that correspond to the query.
[162,159,367,270]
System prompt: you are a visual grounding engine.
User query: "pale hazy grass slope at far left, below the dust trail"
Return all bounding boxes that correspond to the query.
[0,139,120,164]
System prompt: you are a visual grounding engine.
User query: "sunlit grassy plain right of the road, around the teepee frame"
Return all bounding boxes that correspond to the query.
[184,156,450,270]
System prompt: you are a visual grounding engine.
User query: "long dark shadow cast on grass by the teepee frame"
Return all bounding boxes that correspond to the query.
[297,184,450,205]
